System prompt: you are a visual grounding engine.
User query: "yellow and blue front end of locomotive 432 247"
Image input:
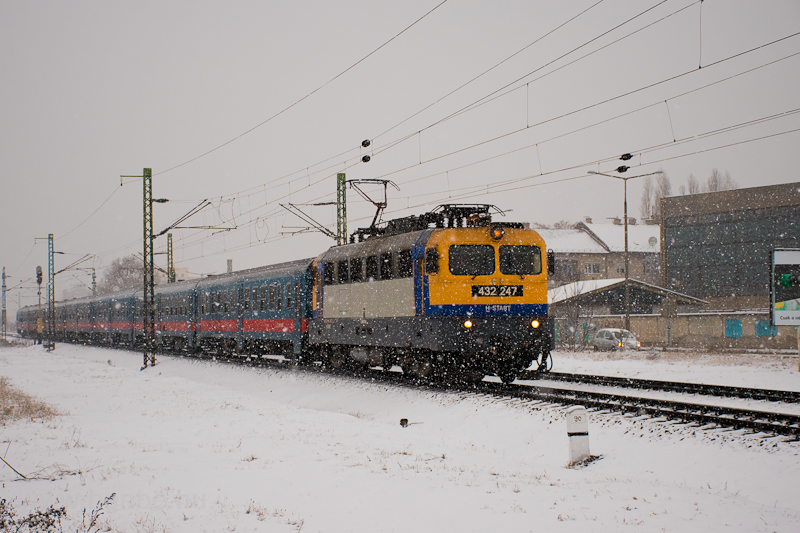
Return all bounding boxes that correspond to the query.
[420,218,551,382]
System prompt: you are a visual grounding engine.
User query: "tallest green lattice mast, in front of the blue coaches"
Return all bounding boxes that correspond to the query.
[142,168,156,370]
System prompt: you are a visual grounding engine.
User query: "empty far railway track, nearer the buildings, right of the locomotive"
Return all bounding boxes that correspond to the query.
[518,372,800,403]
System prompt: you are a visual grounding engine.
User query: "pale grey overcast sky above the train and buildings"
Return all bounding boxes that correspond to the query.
[0,0,800,312]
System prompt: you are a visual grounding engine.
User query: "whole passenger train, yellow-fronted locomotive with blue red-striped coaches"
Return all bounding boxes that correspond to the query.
[17,204,554,383]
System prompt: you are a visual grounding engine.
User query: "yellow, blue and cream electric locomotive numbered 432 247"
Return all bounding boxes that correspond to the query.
[308,204,553,383]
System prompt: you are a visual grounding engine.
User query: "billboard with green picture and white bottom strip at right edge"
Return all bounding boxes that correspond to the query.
[770,249,800,326]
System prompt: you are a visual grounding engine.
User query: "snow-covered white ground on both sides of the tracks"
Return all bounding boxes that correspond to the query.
[0,344,800,532]
